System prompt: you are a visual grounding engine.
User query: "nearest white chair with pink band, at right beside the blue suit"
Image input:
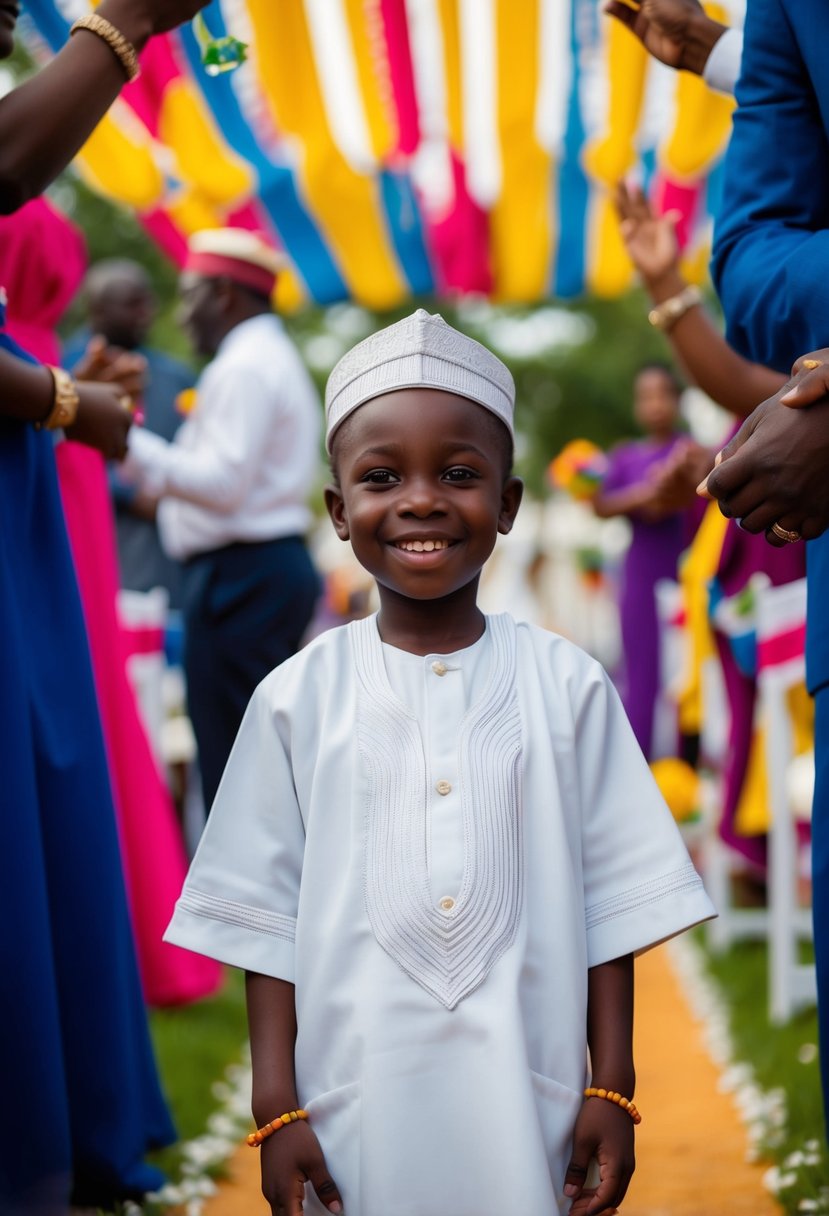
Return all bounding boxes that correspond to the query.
[757,579,817,1025]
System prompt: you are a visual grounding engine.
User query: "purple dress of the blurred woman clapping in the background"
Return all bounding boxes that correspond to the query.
[602,434,692,760]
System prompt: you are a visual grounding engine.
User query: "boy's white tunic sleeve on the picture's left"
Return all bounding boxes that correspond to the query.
[164,675,305,983]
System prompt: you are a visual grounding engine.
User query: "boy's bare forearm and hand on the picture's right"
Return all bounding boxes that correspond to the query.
[564,955,636,1216]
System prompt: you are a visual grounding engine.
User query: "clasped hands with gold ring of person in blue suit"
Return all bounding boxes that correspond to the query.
[699,379,829,547]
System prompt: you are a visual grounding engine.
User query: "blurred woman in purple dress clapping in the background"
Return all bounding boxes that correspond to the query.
[591,364,692,760]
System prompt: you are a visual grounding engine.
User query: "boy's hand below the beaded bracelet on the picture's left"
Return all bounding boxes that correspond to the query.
[260,1122,343,1216]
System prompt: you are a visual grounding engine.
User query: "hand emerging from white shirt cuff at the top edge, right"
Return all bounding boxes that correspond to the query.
[604,0,727,75]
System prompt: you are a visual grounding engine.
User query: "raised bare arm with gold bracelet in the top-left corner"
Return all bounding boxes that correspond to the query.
[0,0,207,215]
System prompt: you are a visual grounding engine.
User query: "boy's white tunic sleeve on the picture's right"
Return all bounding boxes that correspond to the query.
[575,664,716,967]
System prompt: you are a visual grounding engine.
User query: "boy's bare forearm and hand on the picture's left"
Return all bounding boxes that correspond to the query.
[246,972,343,1216]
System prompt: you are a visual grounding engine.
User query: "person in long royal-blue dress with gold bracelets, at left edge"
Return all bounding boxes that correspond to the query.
[0,0,212,1216]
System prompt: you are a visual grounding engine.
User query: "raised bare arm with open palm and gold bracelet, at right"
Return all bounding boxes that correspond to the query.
[614,181,785,418]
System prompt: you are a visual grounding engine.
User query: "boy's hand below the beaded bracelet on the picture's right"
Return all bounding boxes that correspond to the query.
[564,1098,636,1216]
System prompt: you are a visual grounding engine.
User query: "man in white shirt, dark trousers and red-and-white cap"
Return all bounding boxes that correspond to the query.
[126,229,321,806]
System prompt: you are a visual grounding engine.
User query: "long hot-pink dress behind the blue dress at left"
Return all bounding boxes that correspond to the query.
[0,198,221,1006]
